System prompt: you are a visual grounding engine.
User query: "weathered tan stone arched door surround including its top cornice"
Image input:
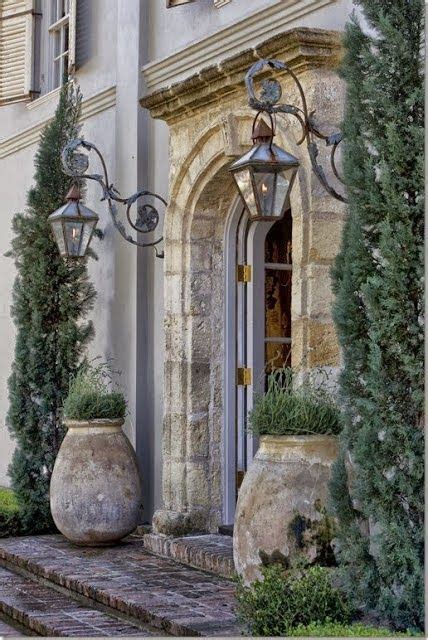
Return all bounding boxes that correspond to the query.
[141,29,344,535]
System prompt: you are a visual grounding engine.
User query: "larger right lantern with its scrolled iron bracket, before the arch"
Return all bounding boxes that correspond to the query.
[229,60,347,215]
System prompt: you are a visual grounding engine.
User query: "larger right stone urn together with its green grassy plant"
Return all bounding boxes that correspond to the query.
[233,368,342,583]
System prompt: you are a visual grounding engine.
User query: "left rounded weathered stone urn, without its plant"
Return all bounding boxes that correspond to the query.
[50,420,141,546]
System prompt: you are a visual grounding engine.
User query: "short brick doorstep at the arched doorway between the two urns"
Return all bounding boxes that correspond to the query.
[142,533,235,578]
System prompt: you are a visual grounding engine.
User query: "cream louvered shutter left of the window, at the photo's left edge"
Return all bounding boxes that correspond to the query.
[0,0,35,105]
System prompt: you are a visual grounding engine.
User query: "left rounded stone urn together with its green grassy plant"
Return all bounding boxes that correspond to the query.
[50,363,141,546]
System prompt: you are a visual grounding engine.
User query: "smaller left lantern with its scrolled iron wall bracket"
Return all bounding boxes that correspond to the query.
[48,138,167,258]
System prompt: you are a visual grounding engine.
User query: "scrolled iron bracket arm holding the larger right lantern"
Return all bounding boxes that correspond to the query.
[245,60,348,202]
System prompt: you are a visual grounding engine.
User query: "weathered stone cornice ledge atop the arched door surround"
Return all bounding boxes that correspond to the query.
[140,28,342,124]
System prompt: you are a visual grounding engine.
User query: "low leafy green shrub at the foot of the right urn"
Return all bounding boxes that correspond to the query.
[236,564,351,636]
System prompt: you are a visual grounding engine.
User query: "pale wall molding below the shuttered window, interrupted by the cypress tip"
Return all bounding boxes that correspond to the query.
[0,87,116,159]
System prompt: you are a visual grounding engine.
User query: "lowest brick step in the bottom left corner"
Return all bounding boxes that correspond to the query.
[0,567,156,637]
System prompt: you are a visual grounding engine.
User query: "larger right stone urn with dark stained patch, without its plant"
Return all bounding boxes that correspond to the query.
[233,436,338,583]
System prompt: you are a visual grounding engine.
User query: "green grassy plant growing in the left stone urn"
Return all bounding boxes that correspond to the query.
[64,363,126,420]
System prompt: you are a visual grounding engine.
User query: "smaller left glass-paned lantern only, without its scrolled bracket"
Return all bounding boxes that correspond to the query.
[48,185,98,258]
